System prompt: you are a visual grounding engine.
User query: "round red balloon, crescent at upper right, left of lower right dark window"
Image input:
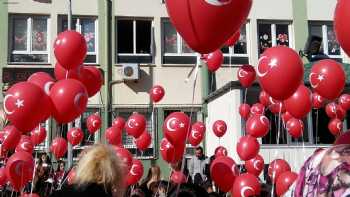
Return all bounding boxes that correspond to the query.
[245,115,270,138]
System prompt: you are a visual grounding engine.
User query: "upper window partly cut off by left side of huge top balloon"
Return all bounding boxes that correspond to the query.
[162,19,197,64]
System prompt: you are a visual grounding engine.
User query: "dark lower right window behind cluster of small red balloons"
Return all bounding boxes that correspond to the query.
[242,87,313,145]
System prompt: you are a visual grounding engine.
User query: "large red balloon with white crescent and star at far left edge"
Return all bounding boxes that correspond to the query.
[3,82,52,132]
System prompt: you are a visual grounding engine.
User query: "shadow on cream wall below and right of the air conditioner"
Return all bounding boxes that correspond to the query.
[125,67,153,93]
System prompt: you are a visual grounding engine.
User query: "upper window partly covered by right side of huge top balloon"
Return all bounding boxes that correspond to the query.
[221,24,249,64]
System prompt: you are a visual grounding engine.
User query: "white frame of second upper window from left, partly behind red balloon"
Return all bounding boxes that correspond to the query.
[57,15,100,65]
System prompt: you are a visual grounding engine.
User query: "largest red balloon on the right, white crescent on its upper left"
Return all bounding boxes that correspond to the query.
[256,46,304,101]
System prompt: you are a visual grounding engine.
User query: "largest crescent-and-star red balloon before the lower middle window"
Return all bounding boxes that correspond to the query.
[163,112,190,146]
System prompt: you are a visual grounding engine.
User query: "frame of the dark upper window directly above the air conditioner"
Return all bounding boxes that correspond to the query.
[116,17,154,59]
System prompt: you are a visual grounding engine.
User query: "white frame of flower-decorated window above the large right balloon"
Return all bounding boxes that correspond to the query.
[257,20,295,56]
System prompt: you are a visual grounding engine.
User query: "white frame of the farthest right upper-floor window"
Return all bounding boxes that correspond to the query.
[308,20,344,60]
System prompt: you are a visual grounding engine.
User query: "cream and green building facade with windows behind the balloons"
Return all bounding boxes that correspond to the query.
[0,0,349,178]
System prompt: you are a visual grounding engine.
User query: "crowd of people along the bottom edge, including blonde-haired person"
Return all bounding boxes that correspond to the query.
[0,145,276,197]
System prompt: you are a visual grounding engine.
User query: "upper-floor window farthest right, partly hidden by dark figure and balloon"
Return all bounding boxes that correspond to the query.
[309,21,342,58]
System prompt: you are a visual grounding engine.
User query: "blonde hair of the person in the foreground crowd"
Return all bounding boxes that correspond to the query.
[74,144,124,194]
